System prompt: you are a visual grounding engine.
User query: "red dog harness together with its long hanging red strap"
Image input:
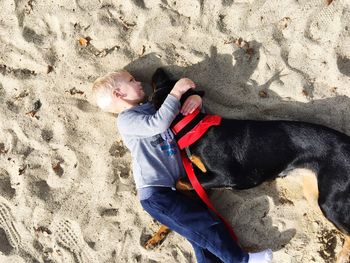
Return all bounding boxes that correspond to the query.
[172,109,237,241]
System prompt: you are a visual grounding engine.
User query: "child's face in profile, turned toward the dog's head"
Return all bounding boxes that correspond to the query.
[118,71,145,104]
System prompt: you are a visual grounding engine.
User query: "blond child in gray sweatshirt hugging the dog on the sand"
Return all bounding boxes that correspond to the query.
[93,71,272,263]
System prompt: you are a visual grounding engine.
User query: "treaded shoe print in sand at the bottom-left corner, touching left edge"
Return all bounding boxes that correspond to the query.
[0,196,43,262]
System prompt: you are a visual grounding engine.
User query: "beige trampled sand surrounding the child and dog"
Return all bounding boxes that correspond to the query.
[0,0,350,263]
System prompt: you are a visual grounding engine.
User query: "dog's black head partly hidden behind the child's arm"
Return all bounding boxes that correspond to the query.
[151,68,204,110]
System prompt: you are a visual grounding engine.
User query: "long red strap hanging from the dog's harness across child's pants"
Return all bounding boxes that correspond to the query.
[181,151,238,241]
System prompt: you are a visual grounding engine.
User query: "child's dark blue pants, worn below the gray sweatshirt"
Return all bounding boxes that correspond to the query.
[141,187,249,263]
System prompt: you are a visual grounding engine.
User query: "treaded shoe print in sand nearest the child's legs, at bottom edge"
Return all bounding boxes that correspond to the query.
[53,218,99,263]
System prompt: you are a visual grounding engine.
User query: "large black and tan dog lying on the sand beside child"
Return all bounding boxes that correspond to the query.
[146,69,350,262]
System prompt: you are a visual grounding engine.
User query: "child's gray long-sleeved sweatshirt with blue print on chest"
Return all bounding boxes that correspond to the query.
[117,94,185,199]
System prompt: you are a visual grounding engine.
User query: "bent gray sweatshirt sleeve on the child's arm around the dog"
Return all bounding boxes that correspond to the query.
[117,94,180,137]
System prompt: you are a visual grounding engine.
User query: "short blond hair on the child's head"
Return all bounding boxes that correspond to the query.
[92,70,126,111]
